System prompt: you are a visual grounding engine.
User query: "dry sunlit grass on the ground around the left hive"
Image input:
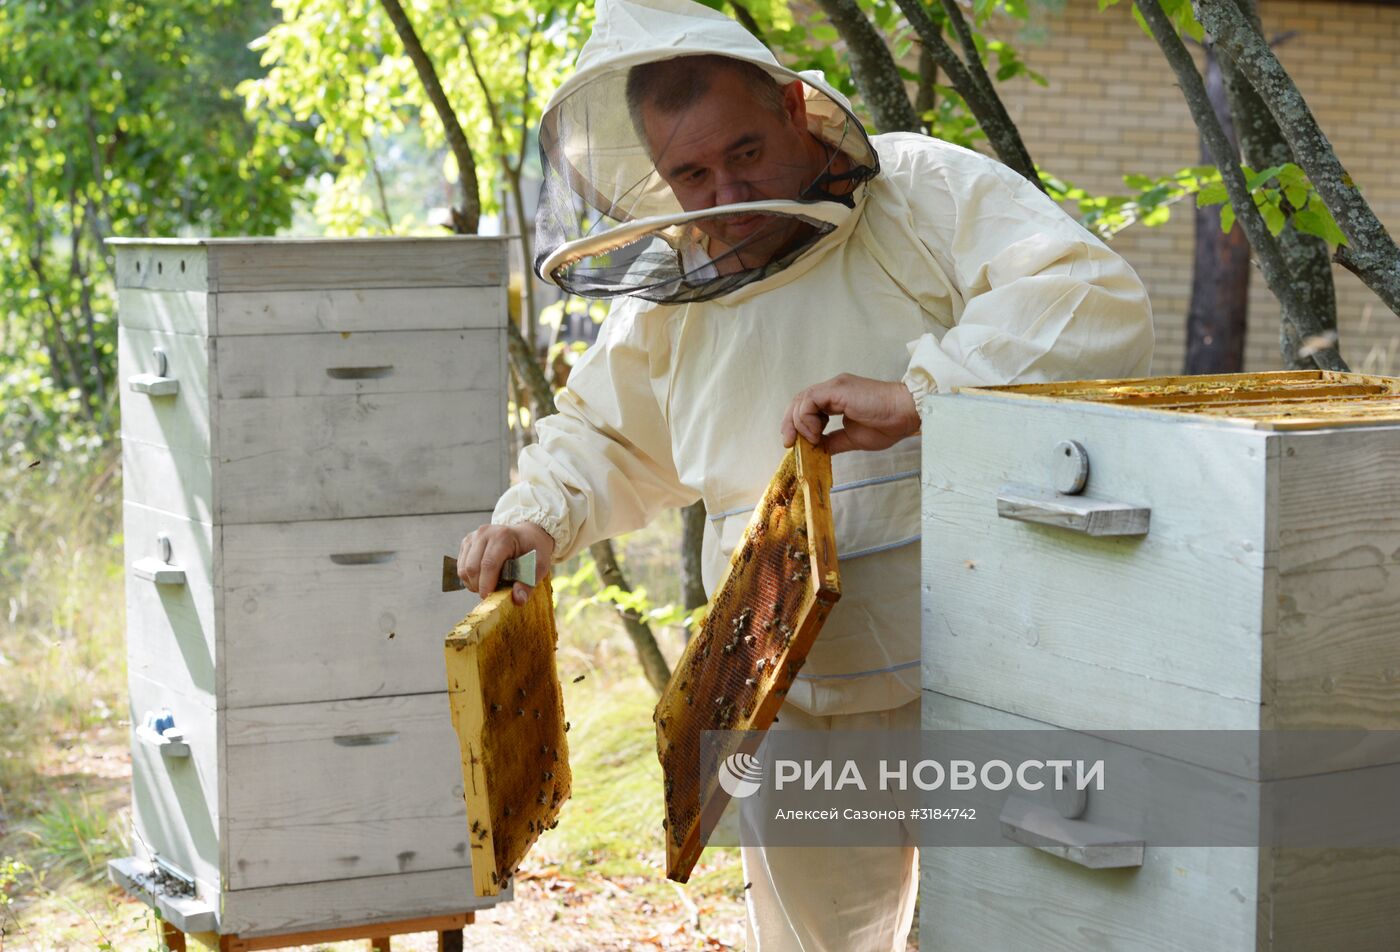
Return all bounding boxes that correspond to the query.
[0,455,742,952]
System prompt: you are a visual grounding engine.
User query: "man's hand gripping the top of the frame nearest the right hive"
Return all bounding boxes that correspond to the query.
[783,374,920,454]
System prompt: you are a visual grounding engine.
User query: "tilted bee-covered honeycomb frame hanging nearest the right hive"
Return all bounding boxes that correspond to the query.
[652,438,841,882]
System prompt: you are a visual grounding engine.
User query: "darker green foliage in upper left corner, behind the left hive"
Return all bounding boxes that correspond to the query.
[0,0,315,464]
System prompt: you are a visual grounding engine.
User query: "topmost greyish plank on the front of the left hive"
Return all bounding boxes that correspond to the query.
[207,237,507,291]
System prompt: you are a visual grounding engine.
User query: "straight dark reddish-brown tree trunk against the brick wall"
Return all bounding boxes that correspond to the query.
[1186,43,1248,374]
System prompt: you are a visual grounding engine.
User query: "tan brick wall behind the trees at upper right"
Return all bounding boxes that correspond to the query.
[1001,0,1400,374]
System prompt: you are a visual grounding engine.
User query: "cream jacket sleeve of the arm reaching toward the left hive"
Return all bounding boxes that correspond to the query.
[491,300,699,561]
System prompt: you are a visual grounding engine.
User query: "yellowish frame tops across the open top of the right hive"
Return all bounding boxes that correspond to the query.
[955,370,1400,430]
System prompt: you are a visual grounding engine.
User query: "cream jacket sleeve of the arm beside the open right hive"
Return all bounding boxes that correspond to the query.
[896,137,1152,400]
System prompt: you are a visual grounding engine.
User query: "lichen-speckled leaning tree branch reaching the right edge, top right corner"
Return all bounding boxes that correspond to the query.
[1193,0,1400,316]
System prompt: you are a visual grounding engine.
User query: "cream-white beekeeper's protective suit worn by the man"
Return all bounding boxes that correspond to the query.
[494,0,1152,949]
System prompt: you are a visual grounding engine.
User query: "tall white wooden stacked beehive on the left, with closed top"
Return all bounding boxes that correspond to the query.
[115,238,508,935]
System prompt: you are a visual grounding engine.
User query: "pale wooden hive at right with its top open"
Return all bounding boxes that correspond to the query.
[921,372,1400,952]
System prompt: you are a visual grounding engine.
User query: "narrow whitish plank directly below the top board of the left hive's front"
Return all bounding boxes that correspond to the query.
[218,284,505,336]
